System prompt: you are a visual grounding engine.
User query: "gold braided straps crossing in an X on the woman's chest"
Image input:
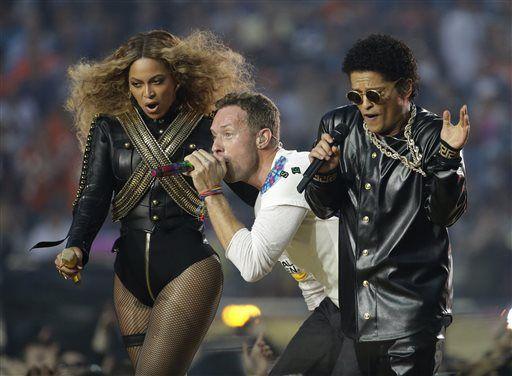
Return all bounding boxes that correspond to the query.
[112,108,202,221]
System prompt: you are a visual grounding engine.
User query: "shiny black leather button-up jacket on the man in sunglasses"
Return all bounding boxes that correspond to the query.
[306,105,467,341]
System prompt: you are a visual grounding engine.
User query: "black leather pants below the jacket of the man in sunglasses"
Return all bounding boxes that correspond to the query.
[332,328,445,376]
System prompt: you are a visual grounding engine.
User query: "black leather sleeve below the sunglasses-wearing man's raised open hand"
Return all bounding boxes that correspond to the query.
[425,125,467,227]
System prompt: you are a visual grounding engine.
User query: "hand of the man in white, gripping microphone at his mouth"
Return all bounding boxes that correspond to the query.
[185,149,227,192]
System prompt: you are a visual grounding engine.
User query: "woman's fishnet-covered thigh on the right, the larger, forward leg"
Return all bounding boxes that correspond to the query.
[135,256,223,375]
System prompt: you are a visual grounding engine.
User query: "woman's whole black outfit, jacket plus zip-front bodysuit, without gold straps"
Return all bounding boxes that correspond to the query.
[47,102,257,306]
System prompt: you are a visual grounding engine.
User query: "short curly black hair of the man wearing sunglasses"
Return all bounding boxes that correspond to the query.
[343,34,420,98]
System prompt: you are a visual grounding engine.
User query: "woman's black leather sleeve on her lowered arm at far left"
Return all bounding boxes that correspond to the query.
[66,118,113,265]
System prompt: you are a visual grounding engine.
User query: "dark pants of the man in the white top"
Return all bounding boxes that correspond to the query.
[270,298,344,376]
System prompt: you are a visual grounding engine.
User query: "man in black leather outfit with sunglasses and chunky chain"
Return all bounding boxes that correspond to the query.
[306,35,469,375]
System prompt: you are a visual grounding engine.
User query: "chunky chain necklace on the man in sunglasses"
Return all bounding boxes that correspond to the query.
[363,103,427,176]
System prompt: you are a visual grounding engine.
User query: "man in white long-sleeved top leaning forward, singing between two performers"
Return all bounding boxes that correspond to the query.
[185,93,343,375]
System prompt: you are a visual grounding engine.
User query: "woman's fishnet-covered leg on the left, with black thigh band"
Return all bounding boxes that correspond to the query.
[114,275,151,368]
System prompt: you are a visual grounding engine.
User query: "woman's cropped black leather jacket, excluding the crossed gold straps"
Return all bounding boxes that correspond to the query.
[66,107,257,265]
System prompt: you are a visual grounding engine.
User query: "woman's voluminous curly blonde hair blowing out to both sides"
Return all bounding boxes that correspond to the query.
[66,30,254,147]
